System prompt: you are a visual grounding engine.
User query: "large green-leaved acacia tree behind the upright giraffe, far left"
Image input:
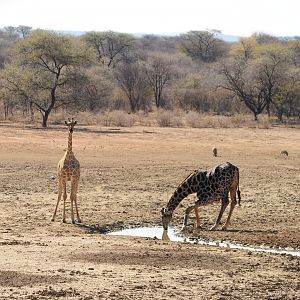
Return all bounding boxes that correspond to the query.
[3,30,92,127]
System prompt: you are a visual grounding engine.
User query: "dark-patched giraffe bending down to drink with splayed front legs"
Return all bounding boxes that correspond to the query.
[161,162,241,230]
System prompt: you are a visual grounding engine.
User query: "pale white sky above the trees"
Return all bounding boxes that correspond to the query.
[0,0,300,36]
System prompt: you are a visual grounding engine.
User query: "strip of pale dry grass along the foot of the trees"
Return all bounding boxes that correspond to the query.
[0,109,299,129]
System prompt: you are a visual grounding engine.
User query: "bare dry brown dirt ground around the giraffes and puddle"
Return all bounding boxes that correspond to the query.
[0,123,300,300]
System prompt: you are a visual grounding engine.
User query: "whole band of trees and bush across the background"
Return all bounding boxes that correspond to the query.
[0,26,300,127]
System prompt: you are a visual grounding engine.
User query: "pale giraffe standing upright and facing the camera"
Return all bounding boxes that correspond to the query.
[51,118,81,224]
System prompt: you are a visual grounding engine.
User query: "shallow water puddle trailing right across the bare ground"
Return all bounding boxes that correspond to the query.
[107,226,300,257]
